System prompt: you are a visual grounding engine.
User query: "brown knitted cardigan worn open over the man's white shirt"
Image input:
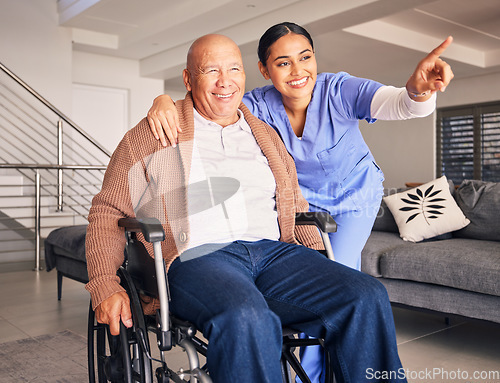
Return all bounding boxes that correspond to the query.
[85,93,323,309]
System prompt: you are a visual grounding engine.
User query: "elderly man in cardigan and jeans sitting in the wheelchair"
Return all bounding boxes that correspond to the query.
[86,35,405,383]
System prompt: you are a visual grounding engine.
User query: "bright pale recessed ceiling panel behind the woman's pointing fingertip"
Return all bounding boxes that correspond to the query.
[343,20,486,68]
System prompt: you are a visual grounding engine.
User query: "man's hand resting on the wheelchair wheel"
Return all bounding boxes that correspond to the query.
[95,291,132,335]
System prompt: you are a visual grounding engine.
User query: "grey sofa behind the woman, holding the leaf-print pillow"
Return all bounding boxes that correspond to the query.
[362,180,500,323]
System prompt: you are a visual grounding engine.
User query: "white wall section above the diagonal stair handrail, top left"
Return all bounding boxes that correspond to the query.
[0,0,71,114]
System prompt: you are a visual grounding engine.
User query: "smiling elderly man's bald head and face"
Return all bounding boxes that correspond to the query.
[183,35,245,126]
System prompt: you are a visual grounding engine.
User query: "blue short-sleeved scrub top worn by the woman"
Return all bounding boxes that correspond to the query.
[243,72,384,215]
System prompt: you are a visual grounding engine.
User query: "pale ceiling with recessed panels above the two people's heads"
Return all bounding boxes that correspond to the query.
[58,0,500,90]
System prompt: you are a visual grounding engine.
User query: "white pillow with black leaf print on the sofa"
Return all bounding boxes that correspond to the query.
[384,176,470,242]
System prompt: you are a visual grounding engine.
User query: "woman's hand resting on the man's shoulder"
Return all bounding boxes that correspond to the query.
[148,94,182,148]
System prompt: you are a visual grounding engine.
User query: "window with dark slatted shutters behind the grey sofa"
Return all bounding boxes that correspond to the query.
[437,102,500,184]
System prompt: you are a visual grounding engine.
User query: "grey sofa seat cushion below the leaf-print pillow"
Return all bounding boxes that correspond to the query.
[380,238,500,296]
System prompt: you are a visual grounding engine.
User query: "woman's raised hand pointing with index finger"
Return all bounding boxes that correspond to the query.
[406,36,453,101]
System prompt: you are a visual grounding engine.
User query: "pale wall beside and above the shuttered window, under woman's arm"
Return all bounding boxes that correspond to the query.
[360,73,500,188]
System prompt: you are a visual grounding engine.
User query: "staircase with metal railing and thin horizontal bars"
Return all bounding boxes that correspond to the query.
[0,63,110,270]
